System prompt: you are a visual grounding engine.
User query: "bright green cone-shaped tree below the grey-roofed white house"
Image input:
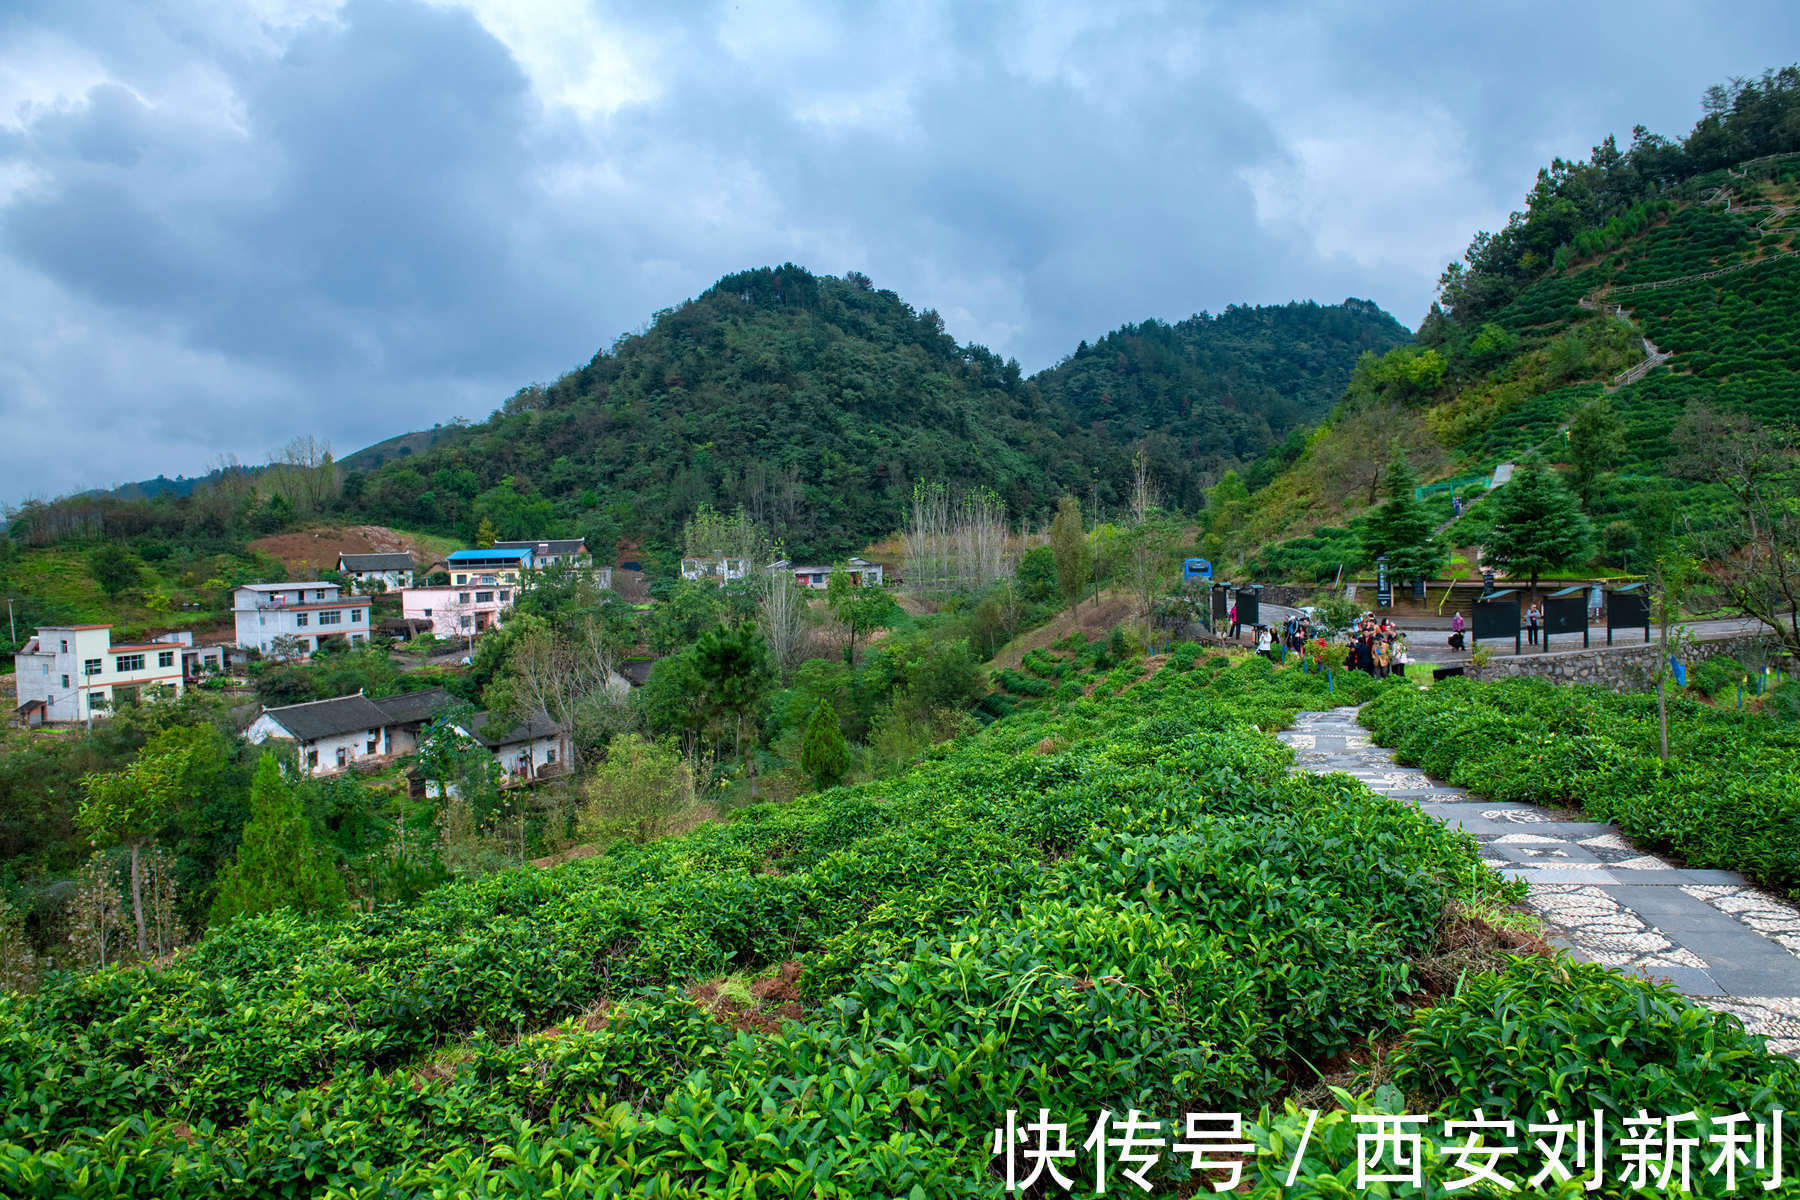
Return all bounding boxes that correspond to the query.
[211,754,349,925]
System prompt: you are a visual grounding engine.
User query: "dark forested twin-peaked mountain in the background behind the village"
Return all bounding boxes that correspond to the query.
[346,264,1408,556]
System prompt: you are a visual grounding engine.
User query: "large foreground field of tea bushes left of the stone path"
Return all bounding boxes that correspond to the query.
[0,662,1800,1198]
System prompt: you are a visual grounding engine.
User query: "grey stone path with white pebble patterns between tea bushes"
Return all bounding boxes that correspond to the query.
[1280,709,1800,1056]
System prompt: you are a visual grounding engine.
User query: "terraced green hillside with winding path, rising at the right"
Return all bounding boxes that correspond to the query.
[1229,68,1800,578]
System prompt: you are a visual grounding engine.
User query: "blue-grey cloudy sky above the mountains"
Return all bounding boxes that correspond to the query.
[0,0,1800,502]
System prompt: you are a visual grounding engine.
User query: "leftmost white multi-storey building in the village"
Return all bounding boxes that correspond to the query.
[13,624,193,725]
